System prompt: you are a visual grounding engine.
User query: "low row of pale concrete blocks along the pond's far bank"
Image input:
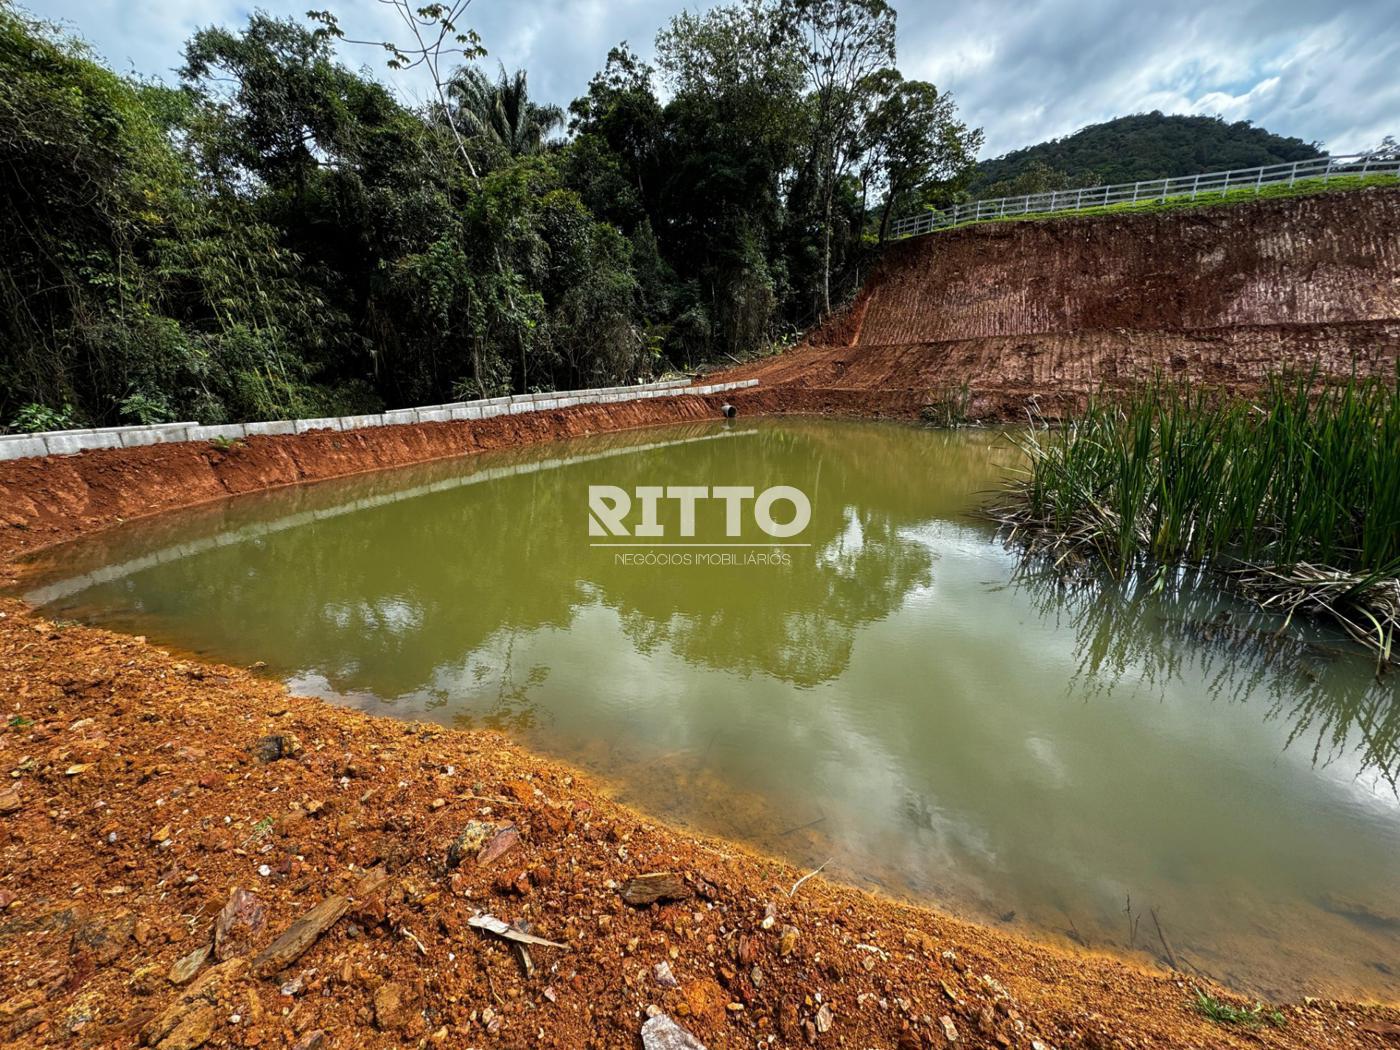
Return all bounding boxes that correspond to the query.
[0,379,759,459]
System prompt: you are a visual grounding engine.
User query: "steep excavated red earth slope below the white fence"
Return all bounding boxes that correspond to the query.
[725,189,1400,417]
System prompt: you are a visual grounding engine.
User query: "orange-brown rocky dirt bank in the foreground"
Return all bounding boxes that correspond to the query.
[0,601,1400,1050]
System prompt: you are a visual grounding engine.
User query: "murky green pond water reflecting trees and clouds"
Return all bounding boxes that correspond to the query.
[28,420,1400,1001]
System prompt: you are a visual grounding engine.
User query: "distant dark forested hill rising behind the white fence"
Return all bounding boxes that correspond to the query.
[970,112,1322,196]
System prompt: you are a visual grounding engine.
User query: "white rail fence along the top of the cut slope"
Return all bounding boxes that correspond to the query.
[890,153,1400,238]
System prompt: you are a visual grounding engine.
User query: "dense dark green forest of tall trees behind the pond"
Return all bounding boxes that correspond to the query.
[0,0,981,430]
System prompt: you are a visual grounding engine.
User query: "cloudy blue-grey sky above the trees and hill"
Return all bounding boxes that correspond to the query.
[18,0,1400,157]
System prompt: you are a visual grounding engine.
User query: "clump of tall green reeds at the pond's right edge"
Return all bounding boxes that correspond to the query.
[998,375,1400,662]
